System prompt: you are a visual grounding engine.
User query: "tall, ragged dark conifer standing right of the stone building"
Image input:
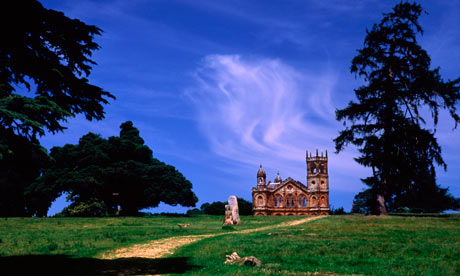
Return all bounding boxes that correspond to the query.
[334,2,460,214]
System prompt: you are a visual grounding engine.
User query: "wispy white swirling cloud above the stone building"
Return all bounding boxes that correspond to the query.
[187,55,368,191]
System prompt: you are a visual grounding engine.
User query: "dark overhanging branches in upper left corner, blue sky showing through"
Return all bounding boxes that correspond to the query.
[0,1,113,137]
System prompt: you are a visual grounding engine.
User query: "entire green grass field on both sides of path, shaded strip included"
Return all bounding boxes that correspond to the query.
[0,215,460,276]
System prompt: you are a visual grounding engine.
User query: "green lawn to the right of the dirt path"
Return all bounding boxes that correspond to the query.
[174,215,460,276]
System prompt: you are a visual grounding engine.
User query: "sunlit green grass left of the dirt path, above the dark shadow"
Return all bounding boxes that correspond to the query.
[0,215,295,257]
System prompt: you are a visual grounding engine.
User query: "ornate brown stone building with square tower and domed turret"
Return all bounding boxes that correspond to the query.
[252,150,329,216]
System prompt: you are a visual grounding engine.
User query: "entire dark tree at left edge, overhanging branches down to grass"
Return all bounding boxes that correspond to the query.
[0,1,114,216]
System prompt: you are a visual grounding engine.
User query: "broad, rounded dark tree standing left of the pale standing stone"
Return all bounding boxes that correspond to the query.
[42,121,198,215]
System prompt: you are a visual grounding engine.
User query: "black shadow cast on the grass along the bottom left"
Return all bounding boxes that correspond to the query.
[0,255,201,276]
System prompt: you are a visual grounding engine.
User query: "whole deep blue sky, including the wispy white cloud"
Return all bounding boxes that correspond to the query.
[41,0,460,215]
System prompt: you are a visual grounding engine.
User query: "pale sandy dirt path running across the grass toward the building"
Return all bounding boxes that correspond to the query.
[101,216,325,259]
